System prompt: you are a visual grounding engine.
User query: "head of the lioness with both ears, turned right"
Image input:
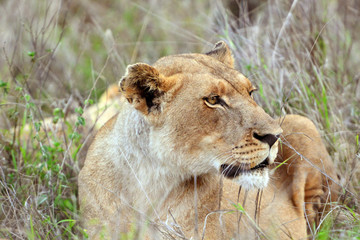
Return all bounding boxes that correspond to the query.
[120,42,282,189]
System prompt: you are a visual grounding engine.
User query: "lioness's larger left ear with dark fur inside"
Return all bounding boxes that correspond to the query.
[119,63,170,115]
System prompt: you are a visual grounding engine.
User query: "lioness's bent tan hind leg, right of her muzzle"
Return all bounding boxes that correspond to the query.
[279,115,339,234]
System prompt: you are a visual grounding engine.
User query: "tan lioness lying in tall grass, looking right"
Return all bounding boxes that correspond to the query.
[79,42,337,239]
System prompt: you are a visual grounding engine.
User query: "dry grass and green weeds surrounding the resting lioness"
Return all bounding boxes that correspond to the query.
[0,0,360,239]
